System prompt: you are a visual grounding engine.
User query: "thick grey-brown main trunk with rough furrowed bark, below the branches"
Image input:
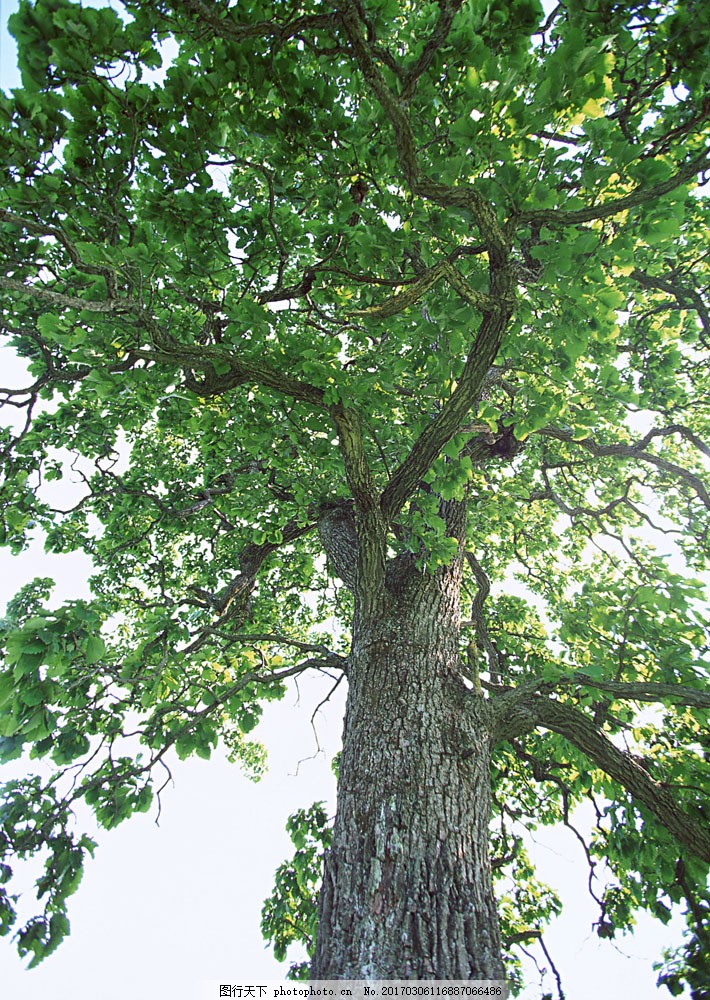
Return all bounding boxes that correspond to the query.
[311,544,503,979]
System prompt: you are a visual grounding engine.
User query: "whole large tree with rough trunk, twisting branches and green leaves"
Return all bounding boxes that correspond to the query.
[0,0,710,996]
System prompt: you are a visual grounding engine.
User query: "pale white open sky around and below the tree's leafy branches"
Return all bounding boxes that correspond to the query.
[0,0,692,1000]
